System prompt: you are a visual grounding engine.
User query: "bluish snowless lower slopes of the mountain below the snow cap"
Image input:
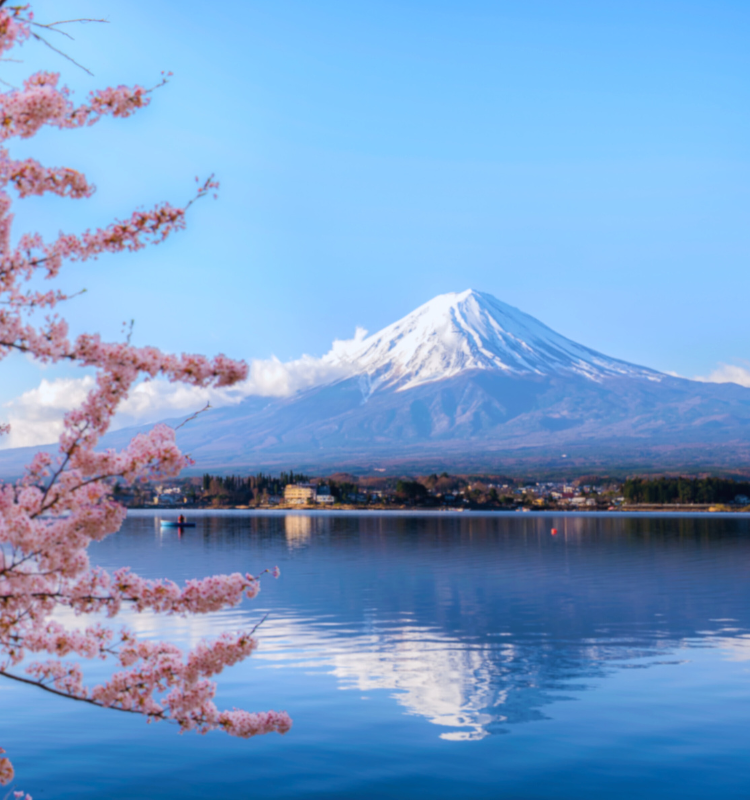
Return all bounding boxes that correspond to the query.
[76,370,750,476]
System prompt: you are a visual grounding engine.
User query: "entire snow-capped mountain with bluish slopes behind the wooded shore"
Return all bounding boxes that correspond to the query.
[0,290,750,471]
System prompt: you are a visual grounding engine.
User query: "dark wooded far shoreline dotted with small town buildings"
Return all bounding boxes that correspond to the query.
[119,470,750,512]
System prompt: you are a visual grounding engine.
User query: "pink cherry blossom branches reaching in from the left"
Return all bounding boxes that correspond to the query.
[0,6,291,797]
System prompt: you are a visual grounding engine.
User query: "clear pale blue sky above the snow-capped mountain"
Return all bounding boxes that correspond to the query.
[0,0,750,438]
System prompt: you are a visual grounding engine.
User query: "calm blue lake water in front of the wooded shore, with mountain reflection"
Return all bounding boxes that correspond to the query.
[0,512,750,800]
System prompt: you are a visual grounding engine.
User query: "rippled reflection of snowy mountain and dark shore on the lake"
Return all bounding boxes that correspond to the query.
[97,513,750,741]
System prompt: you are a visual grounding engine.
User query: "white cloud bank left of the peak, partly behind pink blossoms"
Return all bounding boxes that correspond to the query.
[0,328,367,449]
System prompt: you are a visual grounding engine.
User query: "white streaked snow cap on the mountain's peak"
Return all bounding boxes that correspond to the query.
[324,289,662,396]
